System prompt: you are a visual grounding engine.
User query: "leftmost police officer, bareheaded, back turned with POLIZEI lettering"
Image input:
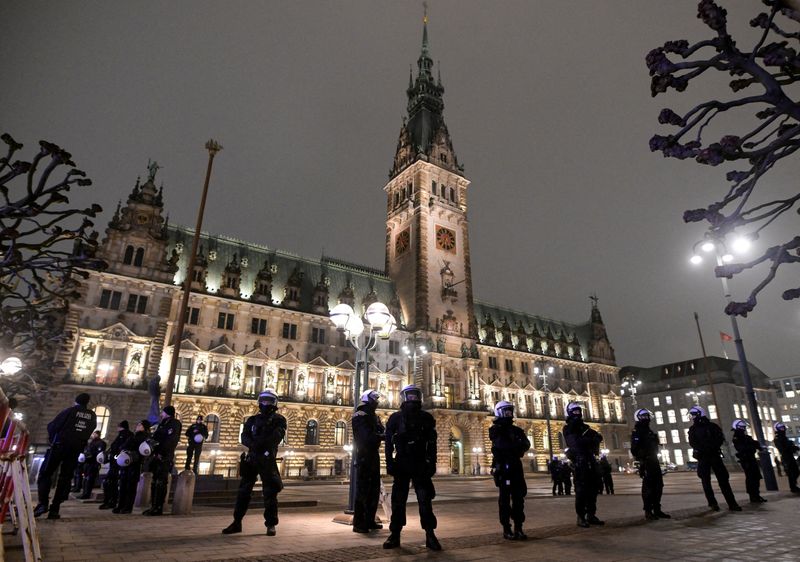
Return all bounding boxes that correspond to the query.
[34,392,97,519]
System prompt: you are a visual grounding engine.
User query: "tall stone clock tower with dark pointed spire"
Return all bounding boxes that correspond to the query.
[384,16,476,337]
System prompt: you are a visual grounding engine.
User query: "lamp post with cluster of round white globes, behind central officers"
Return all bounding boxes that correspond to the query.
[329,302,397,523]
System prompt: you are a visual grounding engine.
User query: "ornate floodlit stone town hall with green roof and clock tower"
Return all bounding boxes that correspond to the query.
[31,17,627,476]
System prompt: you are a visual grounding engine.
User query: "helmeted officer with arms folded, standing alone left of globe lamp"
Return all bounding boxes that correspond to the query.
[222,390,286,537]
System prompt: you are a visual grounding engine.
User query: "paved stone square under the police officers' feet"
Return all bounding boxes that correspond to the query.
[4,473,800,562]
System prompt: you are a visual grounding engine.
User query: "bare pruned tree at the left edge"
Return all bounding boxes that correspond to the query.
[0,134,105,398]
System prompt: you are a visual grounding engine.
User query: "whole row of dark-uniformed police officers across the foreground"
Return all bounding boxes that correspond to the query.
[35,385,800,550]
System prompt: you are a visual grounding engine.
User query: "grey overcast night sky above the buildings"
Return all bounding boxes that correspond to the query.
[0,0,800,376]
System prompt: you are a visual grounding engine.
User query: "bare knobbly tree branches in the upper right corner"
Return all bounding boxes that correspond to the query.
[646,0,800,316]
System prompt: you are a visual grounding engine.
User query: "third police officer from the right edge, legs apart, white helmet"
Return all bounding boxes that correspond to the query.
[689,406,742,511]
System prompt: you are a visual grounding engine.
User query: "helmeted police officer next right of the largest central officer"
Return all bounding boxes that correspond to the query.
[489,400,531,541]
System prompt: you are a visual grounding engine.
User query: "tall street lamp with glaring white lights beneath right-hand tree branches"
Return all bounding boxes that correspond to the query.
[690,235,778,491]
